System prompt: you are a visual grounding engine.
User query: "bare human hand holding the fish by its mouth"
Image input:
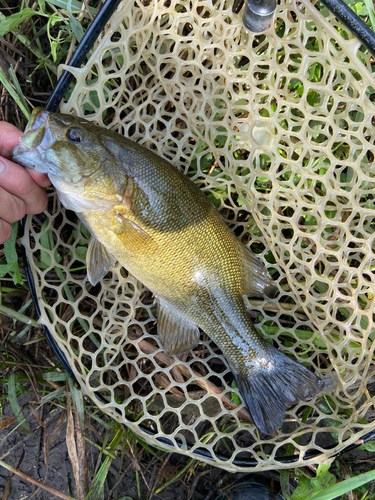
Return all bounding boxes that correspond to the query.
[0,121,50,243]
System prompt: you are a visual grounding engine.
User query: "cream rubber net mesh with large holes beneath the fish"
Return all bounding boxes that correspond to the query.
[24,0,375,471]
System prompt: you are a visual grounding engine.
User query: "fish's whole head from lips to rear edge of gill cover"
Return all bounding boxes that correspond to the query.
[12,108,126,212]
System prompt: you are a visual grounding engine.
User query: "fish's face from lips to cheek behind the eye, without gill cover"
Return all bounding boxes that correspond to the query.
[13,108,103,183]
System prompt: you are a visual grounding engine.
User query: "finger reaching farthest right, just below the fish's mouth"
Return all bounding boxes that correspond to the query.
[0,158,47,214]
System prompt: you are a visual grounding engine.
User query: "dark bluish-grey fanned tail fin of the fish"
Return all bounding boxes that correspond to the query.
[236,345,324,436]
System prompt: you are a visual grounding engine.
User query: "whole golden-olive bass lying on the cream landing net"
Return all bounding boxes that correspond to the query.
[13,108,324,436]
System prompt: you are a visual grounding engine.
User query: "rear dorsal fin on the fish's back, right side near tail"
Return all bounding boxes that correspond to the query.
[240,245,278,298]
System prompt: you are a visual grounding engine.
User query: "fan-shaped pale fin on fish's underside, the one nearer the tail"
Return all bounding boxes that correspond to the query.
[158,300,199,356]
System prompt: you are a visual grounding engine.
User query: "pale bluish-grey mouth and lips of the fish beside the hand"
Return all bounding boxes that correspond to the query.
[12,108,54,173]
